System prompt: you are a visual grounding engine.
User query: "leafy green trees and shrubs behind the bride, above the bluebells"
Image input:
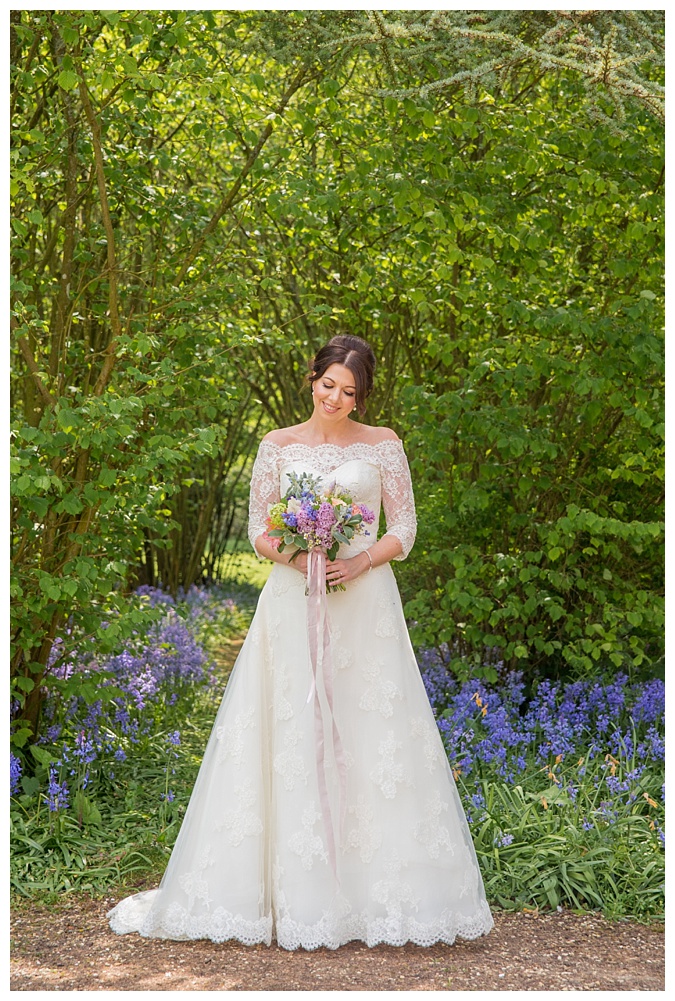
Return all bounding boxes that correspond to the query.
[10,5,664,744]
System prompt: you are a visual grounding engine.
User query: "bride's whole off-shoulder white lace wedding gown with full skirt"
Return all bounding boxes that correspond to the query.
[109,439,493,949]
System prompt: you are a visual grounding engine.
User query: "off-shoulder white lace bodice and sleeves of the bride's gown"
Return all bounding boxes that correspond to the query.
[248,438,417,560]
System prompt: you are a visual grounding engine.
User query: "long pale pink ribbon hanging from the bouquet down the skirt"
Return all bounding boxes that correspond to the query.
[307,550,347,879]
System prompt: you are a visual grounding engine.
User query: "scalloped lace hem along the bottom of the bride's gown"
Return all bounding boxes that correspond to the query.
[108,898,494,951]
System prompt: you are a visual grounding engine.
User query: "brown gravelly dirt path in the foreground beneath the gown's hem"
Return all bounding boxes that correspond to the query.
[10,897,665,991]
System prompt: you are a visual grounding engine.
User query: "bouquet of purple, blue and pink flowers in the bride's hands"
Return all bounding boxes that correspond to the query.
[264,472,375,591]
